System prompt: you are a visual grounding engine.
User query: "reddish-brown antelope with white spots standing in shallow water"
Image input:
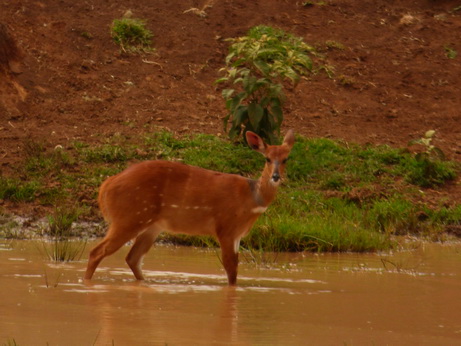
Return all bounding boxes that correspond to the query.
[84,130,295,286]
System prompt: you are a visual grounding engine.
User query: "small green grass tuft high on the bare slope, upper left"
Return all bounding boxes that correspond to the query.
[111,18,153,53]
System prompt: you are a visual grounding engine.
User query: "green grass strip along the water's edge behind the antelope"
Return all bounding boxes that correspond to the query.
[0,132,461,252]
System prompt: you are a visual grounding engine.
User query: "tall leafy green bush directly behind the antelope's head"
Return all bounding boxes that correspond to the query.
[216,25,315,143]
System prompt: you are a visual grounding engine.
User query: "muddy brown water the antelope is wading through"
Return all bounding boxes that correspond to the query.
[0,241,461,345]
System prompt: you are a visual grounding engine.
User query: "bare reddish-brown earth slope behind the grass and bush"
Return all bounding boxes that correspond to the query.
[0,0,461,214]
